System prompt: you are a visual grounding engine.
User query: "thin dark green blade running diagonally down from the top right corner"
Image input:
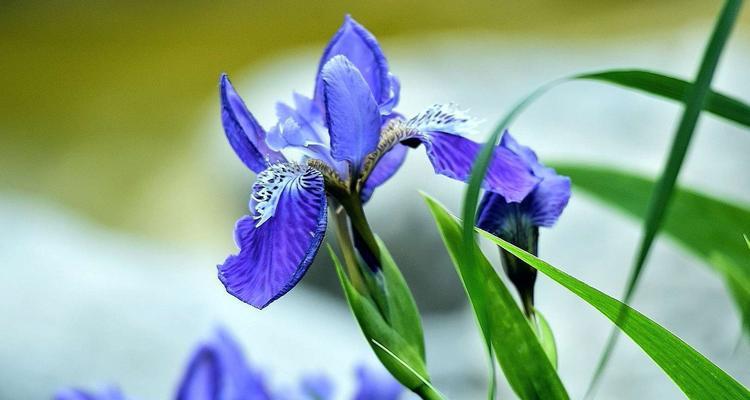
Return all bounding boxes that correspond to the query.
[587,0,742,397]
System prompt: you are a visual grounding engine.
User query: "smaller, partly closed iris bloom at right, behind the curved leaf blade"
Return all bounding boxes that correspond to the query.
[477,132,570,315]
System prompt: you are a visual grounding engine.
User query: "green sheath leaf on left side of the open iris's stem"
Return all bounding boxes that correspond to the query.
[328,245,429,393]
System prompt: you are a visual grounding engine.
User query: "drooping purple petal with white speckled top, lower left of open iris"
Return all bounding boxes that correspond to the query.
[218,163,326,309]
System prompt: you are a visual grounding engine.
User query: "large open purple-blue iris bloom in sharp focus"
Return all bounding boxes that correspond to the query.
[218,16,539,309]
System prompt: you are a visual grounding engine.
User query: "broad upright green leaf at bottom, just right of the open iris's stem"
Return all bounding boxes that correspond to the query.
[423,194,569,399]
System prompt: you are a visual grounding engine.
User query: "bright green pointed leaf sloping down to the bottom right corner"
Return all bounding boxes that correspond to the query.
[477,222,750,400]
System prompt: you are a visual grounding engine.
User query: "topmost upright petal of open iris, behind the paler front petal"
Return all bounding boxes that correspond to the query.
[314,15,398,108]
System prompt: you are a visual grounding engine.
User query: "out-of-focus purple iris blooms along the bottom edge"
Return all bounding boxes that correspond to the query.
[55,330,404,400]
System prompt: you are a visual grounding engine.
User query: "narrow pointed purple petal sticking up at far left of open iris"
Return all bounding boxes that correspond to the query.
[219,74,284,173]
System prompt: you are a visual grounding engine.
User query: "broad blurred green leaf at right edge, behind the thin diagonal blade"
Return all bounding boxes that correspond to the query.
[554,163,750,332]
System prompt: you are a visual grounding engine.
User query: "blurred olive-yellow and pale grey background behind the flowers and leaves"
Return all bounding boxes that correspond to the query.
[0,0,750,400]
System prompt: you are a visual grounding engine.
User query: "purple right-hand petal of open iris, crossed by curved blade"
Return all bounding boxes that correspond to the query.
[418,132,539,202]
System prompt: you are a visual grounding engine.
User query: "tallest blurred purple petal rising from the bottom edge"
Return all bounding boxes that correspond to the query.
[176,330,271,400]
